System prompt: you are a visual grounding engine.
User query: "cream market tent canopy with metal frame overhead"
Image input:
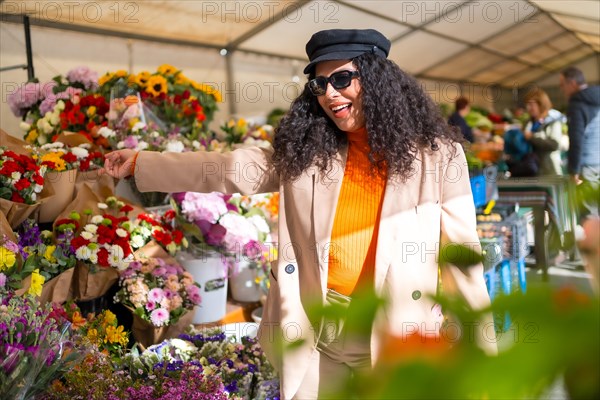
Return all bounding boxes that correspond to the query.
[0,0,600,88]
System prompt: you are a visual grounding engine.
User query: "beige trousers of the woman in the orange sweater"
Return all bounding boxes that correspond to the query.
[294,289,371,400]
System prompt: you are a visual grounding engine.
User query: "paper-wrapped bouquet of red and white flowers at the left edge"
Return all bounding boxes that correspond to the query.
[0,146,52,228]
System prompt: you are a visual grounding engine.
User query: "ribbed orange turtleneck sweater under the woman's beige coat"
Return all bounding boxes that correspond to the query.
[327,129,386,296]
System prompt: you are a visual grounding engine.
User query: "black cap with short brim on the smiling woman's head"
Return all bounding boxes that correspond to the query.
[304,29,391,74]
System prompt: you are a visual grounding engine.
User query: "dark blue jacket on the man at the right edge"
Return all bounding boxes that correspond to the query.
[567,86,600,174]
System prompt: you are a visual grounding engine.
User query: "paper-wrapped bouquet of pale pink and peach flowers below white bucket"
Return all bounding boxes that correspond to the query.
[115,258,201,347]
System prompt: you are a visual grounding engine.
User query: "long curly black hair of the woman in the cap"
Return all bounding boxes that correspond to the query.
[272,53,461,181]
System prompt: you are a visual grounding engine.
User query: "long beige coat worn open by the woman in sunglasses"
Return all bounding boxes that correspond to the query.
[135,143,495,398]
